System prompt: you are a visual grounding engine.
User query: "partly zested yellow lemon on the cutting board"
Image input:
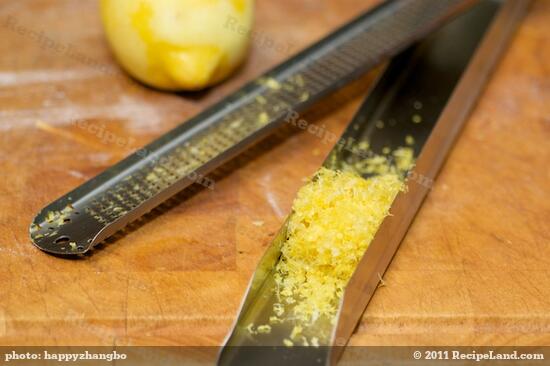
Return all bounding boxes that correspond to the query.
[101,0,254,90]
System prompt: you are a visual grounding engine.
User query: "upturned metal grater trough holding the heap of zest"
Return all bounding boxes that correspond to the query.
[218,0,527,366]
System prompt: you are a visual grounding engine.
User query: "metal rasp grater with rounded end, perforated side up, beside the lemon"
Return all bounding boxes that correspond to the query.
[30,0,472,255]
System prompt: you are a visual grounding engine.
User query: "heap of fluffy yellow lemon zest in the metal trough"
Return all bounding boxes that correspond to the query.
[275,168,404,325]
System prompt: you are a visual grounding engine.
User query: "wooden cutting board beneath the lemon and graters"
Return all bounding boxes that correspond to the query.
[0,0,550,352]
